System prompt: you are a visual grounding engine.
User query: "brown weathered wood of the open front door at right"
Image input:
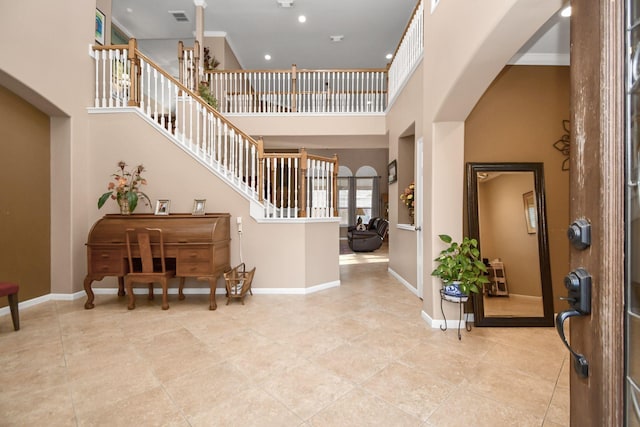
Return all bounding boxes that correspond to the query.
[568,0,624,426]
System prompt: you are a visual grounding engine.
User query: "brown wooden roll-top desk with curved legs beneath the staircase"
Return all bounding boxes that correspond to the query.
[84,213,231,310]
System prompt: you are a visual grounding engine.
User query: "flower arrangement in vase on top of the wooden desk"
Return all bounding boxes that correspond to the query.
[98,161,150,215]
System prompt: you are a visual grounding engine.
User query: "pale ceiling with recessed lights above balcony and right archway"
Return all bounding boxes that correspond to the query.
[112,0,569,69]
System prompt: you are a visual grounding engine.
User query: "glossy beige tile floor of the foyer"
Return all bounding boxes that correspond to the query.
[0,249,569,427]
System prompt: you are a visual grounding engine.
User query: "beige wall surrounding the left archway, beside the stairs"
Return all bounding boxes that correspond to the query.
[0,0,96,300]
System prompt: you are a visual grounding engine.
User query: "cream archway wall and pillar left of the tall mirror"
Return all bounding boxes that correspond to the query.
[416,0,562,323]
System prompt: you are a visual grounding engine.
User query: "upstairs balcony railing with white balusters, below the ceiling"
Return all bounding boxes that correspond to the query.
[192,0,424,114]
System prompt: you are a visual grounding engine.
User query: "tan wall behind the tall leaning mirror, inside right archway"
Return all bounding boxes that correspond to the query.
[465,66,570,312]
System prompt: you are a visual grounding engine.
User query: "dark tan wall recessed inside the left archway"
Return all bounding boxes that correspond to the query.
[0,86,51,306]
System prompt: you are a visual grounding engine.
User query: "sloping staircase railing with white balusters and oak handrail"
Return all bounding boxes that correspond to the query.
[93,39,338,219]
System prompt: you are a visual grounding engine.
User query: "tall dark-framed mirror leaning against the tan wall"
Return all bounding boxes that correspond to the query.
[466,163,554,326]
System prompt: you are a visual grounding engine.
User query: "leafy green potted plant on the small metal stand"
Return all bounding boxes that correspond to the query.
[431,234,489,297]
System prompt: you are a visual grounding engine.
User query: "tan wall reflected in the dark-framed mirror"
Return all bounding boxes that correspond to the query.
[477,172,542,297]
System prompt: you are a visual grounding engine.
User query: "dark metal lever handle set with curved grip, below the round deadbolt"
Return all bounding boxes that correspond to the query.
[556,268,591,378]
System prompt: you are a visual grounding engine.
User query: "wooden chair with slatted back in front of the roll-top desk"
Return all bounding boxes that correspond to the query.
[124,228,175,310]
